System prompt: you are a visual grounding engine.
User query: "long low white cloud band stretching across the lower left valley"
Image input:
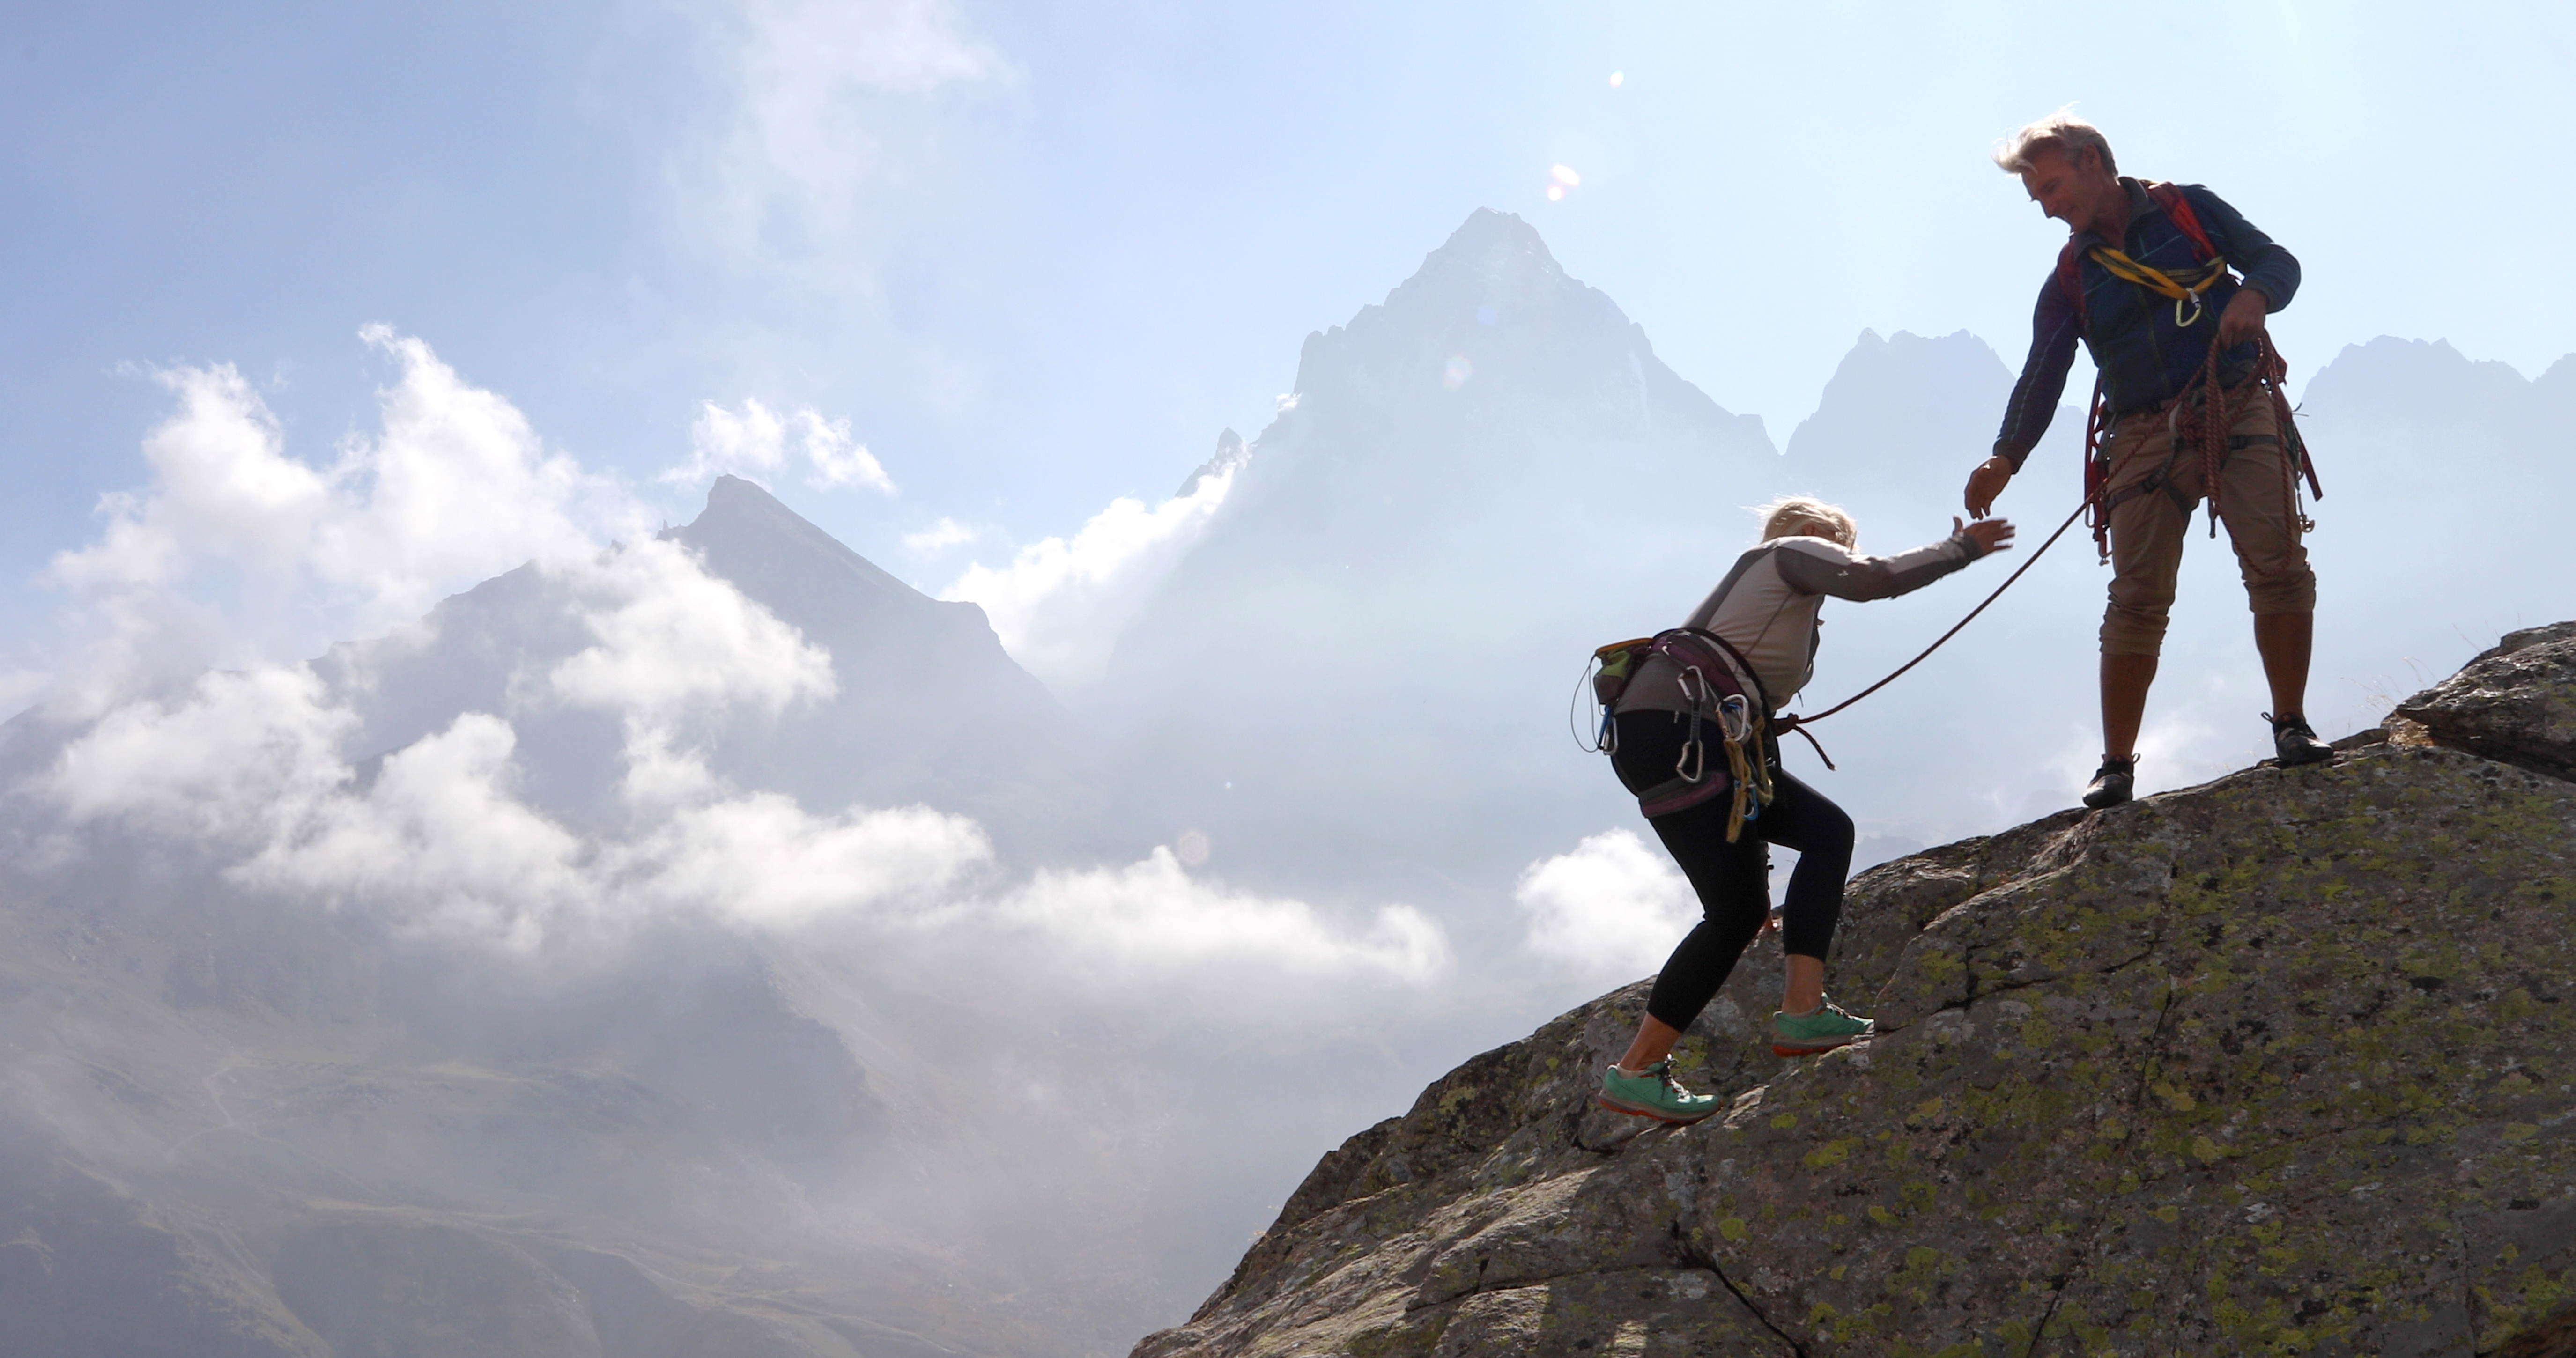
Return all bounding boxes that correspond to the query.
[46,644,1451,1003]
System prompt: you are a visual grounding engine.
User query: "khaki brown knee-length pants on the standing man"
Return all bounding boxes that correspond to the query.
[2102,391,2316,655]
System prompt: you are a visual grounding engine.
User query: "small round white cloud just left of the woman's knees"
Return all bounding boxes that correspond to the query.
[1512,830,1700,984]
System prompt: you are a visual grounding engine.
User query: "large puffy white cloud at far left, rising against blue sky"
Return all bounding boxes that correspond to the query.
[49,325,647,714]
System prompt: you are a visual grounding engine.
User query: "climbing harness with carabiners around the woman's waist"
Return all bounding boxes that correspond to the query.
[1592,626,1772,842]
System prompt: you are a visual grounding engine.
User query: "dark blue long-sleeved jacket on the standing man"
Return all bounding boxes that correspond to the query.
[1994,178,2298,466]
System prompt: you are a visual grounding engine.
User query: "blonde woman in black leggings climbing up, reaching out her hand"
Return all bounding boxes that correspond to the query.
[1600,497,2012,1123]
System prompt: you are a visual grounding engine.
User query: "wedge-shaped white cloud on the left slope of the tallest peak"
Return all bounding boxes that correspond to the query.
[940,461,1242,686]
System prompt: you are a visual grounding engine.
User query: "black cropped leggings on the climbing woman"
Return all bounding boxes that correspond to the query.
[1613,711,1852,1028]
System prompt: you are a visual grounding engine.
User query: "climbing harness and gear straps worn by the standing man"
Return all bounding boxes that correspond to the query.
[2058,183,2326,562]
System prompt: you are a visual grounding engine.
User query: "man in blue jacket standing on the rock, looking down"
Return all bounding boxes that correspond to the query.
[1966,113,2334,806]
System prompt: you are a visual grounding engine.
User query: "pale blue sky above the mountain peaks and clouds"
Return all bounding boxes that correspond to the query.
[0,0,2576,680]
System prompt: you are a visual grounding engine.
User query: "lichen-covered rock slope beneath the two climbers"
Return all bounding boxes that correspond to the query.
[1136,624,2576,1358]
